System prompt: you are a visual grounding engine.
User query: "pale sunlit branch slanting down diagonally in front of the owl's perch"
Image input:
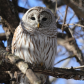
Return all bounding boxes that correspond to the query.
[0,48,41,84]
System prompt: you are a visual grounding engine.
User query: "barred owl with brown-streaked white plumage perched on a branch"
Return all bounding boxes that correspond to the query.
[12,7,57,84]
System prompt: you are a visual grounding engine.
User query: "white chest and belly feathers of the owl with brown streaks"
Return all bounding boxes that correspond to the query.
[15,30,56,67]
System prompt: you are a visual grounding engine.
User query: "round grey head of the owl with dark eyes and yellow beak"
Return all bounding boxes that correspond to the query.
[21,7,56,35]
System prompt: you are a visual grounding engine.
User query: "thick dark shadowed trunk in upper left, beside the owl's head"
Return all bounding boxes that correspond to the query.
[0,0,19,32]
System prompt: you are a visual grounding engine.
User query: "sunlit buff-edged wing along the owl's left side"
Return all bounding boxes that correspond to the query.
[12,25,22,54]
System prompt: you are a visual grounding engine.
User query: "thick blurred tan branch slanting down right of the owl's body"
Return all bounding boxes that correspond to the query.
[57,33,84,65]
